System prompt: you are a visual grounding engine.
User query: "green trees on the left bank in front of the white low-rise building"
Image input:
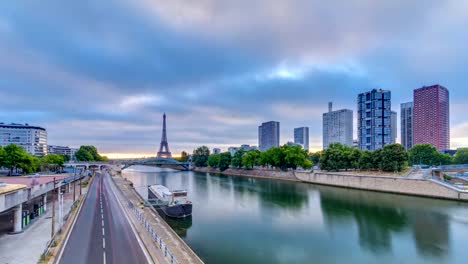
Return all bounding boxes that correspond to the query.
[0,144,107,176]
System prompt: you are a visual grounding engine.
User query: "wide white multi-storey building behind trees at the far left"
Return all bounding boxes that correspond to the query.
[0,123,47,157]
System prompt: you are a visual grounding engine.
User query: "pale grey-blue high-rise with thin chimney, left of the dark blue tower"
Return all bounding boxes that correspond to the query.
[323,102,353,149]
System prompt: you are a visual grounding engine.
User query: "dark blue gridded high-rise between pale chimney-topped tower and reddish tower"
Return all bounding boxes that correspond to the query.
[357,89,392,150]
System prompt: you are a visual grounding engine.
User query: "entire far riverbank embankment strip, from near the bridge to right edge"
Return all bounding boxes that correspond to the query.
[194,167,468,201]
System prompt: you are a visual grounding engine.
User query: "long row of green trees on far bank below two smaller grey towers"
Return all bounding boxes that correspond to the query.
[192,145,312,171]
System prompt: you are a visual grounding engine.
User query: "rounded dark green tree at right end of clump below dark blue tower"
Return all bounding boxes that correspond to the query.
[374,144,408,171]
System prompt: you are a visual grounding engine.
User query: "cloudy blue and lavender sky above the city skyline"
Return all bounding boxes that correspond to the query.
[0,0,468,157]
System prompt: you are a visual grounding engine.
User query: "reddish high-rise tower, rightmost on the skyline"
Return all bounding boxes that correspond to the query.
[413,84,450,150]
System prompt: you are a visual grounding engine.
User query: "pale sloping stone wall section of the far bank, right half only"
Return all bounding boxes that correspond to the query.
[295,172,468,201]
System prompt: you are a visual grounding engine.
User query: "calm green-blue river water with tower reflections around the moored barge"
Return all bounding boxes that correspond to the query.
[123,166,468,264]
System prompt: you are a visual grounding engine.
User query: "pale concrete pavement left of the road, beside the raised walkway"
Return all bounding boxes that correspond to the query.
[0,182,87,264]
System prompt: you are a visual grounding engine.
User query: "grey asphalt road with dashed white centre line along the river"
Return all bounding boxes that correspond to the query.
[59,173,148,264]
